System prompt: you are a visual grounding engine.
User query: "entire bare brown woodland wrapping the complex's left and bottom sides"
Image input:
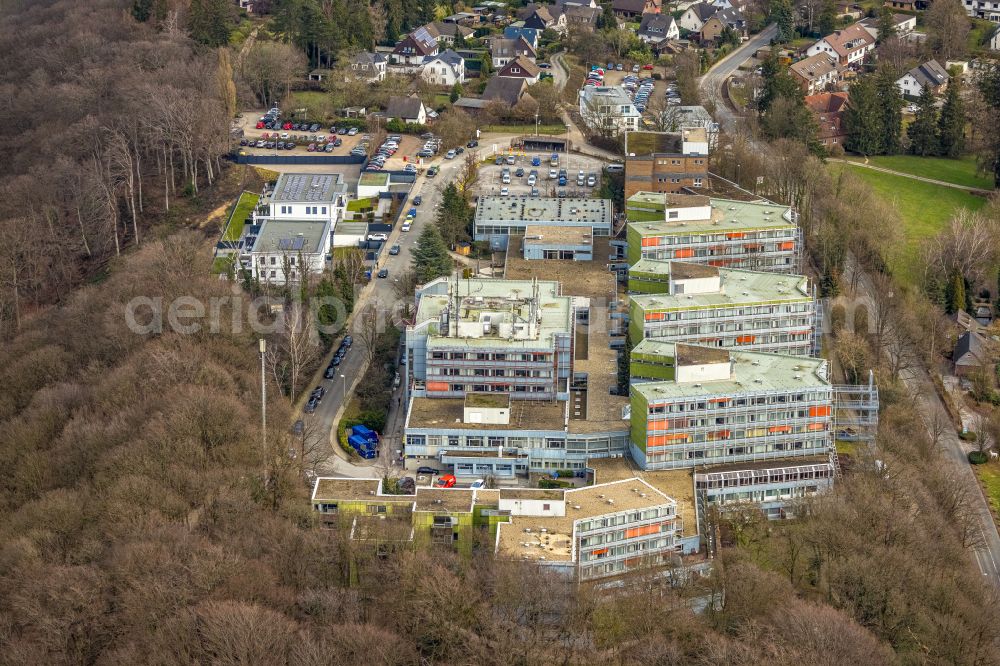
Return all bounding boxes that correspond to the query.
[0,0,1000,666]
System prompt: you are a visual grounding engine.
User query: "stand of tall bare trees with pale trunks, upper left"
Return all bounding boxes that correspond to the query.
[0,0,235,335]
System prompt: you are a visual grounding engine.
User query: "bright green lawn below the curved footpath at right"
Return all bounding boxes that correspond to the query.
[831,164,986,284]
